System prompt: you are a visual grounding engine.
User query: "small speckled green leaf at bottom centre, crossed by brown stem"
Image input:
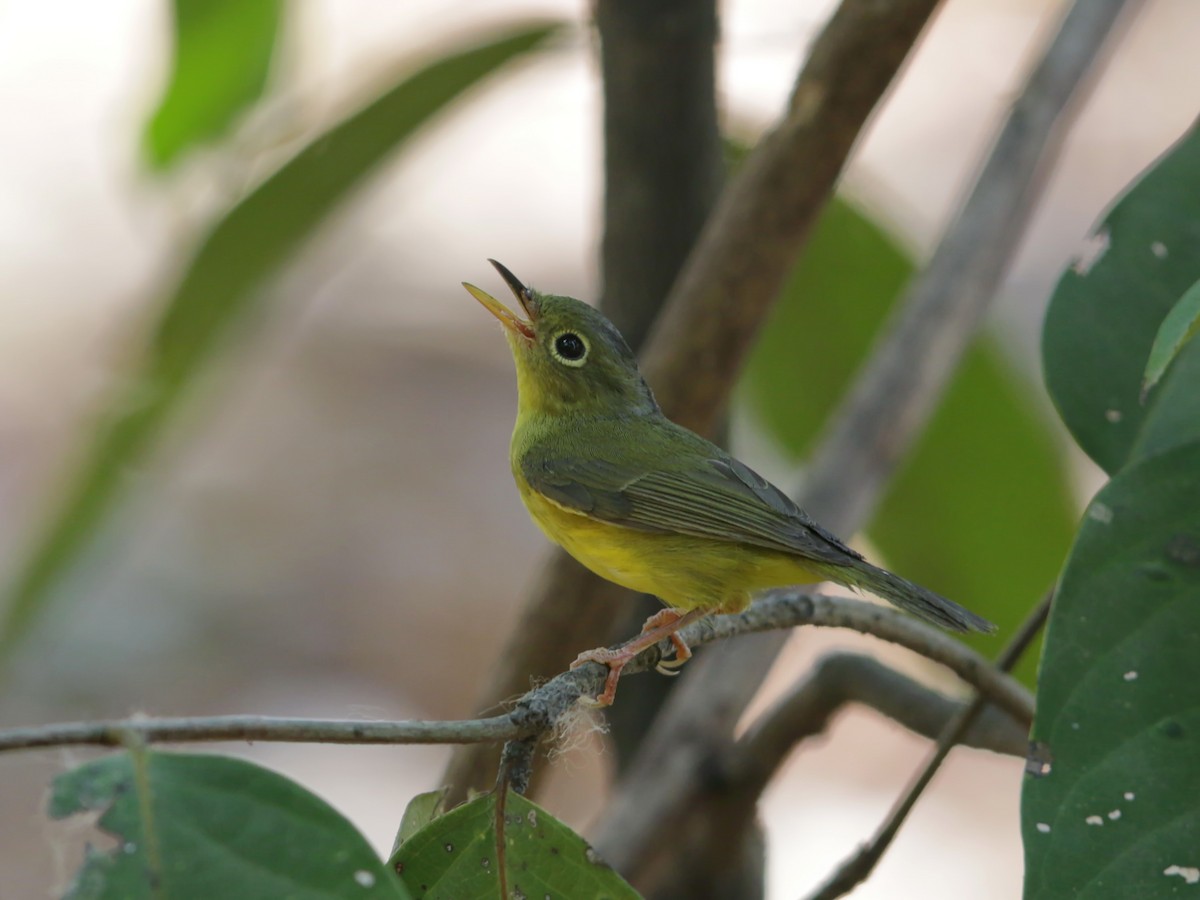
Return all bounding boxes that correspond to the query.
[390,793,637,900]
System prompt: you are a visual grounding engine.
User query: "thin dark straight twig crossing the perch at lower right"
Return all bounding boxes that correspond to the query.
[810,592,1054,900]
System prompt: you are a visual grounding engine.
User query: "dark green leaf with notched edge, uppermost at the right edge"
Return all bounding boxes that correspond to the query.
[1042,128,1200,474]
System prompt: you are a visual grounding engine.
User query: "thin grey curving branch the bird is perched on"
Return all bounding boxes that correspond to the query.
[0,590,1033,752]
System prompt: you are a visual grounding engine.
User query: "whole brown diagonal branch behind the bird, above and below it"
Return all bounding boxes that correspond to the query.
[436,0,937,797]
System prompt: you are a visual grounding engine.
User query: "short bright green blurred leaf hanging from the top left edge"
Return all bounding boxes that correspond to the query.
[144,0,282,168]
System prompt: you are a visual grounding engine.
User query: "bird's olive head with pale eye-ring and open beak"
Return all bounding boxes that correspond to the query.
[463,259,658,414]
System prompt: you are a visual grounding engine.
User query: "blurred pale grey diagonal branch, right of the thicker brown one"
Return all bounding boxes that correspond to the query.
[595,0,1122,889]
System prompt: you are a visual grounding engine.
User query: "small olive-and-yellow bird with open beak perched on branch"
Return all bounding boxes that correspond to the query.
[463,259,995,707]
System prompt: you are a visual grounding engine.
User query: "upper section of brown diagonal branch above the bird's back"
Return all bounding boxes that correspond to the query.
[643,0,937,433]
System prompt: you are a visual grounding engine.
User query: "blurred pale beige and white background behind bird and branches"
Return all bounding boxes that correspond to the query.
[0,0,1200,900]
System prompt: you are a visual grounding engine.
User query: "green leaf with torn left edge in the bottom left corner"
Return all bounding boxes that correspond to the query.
[50,750,409,900]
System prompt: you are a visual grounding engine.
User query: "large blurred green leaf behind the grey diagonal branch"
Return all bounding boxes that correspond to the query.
[743,199,1074,683]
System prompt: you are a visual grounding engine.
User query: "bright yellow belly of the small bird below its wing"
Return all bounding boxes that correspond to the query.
[517,479,823,612]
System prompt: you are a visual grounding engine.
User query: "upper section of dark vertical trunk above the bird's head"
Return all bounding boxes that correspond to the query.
[595,0,724,350]
